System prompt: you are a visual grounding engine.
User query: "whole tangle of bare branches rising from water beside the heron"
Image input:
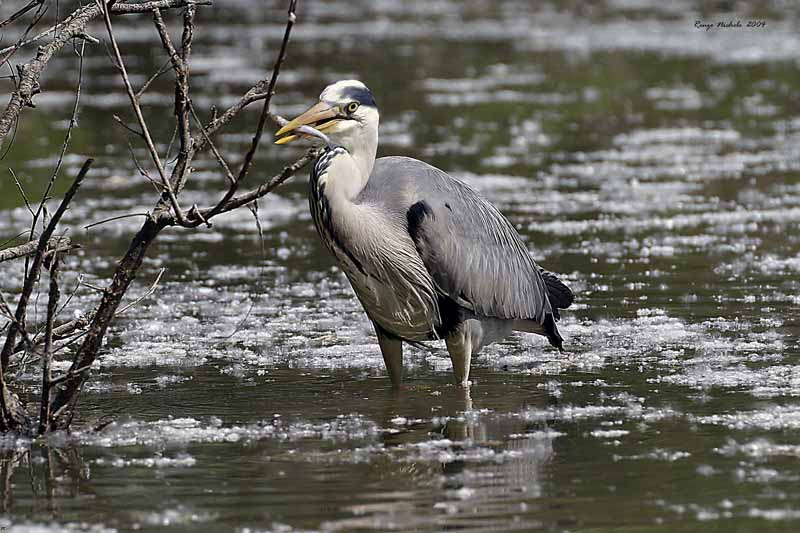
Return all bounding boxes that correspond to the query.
[0,0,315,434]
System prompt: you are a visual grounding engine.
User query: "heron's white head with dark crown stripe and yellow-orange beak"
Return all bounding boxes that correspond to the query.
[275,80,378,153]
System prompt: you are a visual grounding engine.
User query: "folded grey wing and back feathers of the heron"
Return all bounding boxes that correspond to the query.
[363,157,553,324]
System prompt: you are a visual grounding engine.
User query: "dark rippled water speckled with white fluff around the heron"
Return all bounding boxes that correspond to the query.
[0,0,800,532]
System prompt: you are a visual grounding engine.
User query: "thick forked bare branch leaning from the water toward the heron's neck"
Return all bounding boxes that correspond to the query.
[41,0,310,427]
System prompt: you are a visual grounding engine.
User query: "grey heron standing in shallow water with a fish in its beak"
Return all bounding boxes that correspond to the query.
[275,80,574,386]
